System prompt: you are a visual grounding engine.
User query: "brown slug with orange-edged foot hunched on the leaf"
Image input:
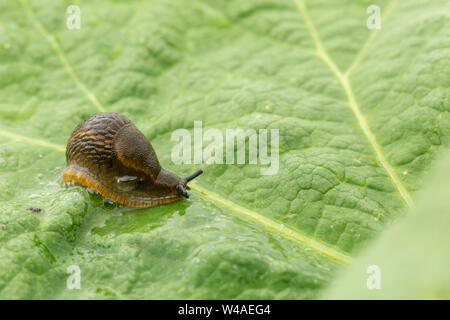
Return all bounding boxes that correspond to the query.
[63,112,203,207]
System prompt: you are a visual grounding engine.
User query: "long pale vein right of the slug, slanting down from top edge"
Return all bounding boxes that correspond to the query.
[295,0,414,208]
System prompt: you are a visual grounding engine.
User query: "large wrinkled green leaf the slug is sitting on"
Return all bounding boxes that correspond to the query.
[0,0,450,298]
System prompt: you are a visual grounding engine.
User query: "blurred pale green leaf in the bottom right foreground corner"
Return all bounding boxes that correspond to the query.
[325,154,450,299]
